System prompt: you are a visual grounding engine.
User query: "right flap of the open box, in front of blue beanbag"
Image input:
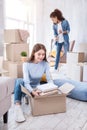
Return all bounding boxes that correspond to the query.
[58,83,75,94]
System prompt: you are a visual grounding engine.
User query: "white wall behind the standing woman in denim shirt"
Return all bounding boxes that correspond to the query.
[36,0,87,50]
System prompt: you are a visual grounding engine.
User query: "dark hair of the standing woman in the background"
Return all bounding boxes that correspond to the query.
[50,9,65,21]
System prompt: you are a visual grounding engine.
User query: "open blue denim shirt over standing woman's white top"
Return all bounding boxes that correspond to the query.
[53,20,70,42]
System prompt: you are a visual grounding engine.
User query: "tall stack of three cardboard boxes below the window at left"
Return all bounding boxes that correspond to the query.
[3,29,29,78]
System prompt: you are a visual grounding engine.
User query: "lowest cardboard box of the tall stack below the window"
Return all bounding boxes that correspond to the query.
[3,61,23,78]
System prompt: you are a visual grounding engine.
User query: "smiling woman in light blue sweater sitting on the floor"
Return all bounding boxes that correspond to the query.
[14,44,53,122]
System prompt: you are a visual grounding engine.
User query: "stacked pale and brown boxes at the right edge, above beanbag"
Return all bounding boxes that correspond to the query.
[66,44,87,81]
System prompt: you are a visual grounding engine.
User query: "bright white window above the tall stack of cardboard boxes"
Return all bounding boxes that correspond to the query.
[5,0,34,55]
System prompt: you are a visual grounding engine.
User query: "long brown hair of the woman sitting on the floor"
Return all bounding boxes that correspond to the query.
[28,43,47,62]
